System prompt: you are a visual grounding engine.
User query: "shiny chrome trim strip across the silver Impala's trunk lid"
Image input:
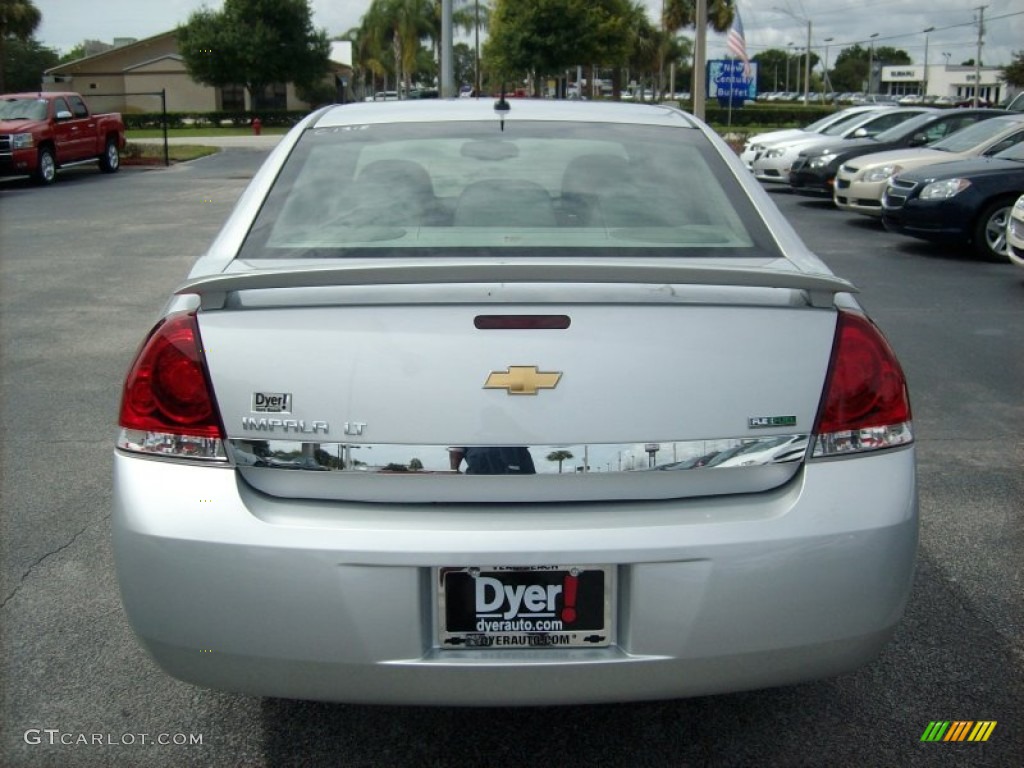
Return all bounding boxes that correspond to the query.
[228,434,810,475]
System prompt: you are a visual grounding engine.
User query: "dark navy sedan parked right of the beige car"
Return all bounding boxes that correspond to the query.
[882,143,1024,261]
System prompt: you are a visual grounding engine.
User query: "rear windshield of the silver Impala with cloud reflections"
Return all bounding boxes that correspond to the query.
[240,120,778,259]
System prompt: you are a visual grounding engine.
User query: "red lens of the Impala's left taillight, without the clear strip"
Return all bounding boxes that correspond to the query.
[119,314,223,438]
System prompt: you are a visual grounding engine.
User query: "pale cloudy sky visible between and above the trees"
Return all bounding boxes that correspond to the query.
[34,0,1024,67]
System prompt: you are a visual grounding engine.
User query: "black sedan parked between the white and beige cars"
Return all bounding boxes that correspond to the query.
[790,110,1007,198]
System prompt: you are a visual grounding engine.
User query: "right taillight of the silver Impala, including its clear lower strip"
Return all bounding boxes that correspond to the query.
[813,311,913,457]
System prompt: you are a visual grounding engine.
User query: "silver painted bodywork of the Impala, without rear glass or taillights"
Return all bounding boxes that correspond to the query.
[113,99,918,706]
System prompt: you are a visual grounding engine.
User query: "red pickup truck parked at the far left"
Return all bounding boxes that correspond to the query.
[0,93,125,184]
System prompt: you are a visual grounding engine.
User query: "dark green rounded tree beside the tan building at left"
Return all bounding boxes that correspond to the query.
[177,0,331,108]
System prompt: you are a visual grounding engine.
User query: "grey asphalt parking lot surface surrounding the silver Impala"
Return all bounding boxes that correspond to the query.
[0,148,1024,768]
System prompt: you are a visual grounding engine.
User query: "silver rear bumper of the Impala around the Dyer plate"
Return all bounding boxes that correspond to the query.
[114,446,918,705]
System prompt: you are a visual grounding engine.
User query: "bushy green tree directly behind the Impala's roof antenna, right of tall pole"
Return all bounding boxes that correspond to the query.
[484,0,631,95]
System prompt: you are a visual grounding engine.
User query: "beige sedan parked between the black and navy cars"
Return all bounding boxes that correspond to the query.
[834,113,1024,216]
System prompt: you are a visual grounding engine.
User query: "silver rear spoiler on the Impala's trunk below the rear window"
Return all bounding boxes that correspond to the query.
[174,261,857,310]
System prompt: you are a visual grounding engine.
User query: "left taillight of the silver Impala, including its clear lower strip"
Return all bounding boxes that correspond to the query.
[118,313,224,461]
